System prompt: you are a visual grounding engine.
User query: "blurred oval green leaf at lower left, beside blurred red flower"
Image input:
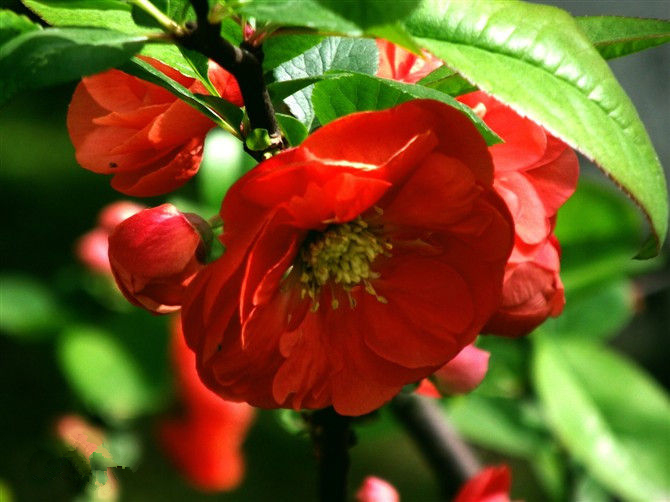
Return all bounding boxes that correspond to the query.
[58,327,161,420]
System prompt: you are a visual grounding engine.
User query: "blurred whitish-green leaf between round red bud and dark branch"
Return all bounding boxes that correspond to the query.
[196,129,256,211]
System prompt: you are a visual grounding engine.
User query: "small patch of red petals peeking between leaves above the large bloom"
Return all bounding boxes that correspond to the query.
[377,39,444,84]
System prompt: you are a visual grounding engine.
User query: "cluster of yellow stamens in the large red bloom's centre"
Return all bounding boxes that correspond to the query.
[299,216,391,310]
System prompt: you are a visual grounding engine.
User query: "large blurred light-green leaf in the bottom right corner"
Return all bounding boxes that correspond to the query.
[533,337,670,500]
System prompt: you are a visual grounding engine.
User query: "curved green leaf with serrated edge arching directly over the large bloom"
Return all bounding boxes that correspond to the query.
[312,73,500,145]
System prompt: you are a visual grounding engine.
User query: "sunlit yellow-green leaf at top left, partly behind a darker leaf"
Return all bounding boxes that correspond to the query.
[23,0,198,77]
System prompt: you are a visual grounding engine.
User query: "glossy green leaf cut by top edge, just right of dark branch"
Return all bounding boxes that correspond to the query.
[235,0,419,50]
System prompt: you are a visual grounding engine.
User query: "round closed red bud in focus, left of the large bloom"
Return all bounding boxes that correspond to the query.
[109,204,211,314]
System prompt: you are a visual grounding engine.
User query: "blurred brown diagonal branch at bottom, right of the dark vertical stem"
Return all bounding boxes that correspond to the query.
[390,393,481,500]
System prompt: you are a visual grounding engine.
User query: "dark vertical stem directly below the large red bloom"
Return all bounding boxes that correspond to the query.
[308,408,354,502]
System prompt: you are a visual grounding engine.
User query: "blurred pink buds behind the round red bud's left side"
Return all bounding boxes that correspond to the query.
[76,201,145,277]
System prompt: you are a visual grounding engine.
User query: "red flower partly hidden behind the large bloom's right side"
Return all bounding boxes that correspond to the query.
[458,92,579,336]
